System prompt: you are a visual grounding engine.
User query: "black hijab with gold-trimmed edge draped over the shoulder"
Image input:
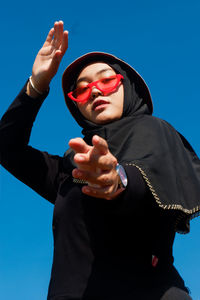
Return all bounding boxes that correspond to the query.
[63,54,200,233]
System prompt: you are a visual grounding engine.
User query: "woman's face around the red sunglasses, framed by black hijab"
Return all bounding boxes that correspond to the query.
[74,62,124,124]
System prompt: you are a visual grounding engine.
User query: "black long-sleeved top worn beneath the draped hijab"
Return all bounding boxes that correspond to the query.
[0,84,191,300]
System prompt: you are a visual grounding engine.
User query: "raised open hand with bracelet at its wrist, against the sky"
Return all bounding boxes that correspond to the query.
[27,21,68,92]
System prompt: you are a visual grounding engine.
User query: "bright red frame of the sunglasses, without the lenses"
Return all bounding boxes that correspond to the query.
[67,74,124,103]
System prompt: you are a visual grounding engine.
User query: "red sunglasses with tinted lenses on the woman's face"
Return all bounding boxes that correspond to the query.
[67,74,124,102]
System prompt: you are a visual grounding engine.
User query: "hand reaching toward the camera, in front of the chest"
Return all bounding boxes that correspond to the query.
[69,135,124,200]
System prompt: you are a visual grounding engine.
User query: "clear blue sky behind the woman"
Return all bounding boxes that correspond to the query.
[0,0,200,300]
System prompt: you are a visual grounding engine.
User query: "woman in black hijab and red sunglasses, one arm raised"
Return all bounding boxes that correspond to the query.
[0,21,200,300]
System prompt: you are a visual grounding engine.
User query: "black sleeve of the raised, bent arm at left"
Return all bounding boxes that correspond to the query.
[0,85,65,203]
